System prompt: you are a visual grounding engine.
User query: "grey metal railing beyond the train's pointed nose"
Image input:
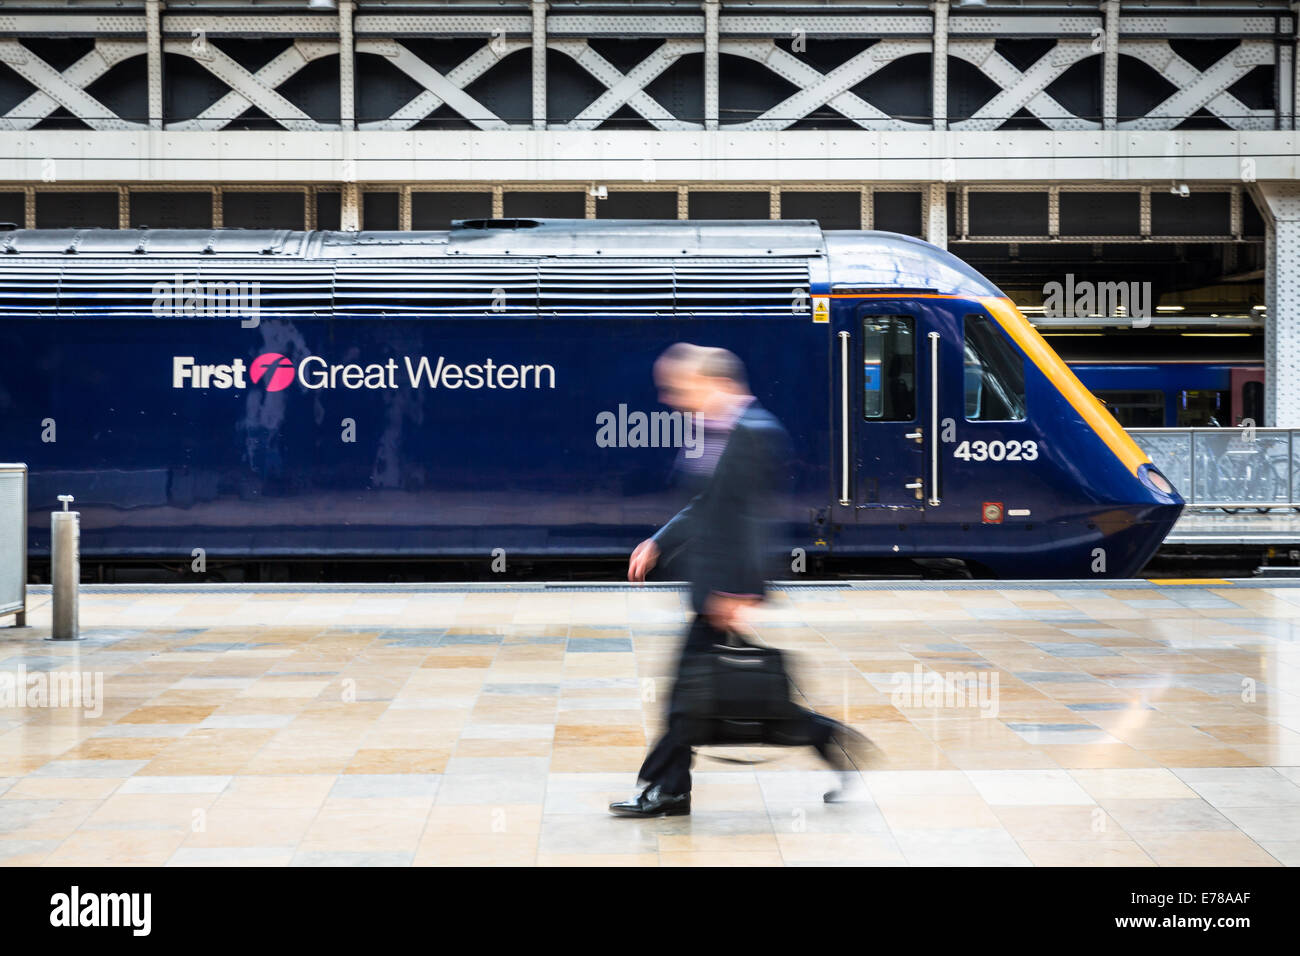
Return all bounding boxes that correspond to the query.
[1128,428,1300,509]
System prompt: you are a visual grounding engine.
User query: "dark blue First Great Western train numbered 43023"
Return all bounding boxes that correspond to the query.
[0,220,1183,578]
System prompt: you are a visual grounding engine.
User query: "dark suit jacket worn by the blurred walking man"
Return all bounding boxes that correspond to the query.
[654,401,789,613]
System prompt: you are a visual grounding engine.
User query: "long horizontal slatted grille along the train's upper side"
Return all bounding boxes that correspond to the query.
[0,255,811,319]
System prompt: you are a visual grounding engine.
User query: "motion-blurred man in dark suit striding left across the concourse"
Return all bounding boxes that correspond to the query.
[610,345,852,817]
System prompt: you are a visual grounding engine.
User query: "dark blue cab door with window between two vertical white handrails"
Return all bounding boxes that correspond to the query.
[832,299,931,523]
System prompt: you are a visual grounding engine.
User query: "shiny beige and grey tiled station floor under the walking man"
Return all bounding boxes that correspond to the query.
[0,583,1300,866]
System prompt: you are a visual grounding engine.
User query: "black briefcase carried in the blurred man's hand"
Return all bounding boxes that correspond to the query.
[673,634,803,747]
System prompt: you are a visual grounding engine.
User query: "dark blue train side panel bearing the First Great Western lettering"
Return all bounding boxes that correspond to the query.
[0,313,829,559]
